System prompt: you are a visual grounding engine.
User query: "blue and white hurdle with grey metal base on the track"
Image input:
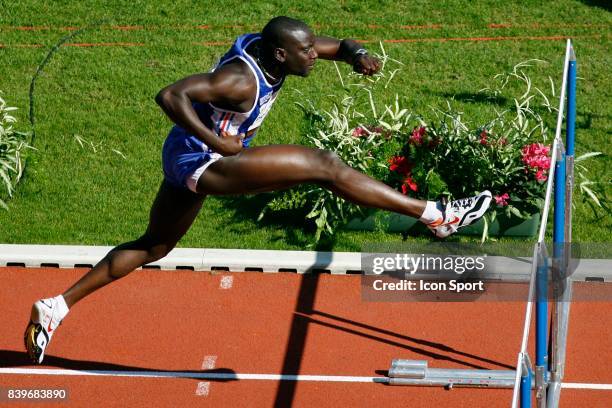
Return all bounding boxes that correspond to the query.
[388,39,576,408]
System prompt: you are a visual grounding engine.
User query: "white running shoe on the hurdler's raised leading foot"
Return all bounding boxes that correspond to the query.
[427,190,492,238]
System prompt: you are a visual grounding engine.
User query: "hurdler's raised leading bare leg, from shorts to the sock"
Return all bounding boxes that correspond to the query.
[198,145,427,218]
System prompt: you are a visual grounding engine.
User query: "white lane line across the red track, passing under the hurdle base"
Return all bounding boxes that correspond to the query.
[0,368,612,390]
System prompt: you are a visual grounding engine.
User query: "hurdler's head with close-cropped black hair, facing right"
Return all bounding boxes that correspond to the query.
[261,16,318,76]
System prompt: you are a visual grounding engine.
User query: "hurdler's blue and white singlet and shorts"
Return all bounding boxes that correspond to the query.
[162,34,284,190]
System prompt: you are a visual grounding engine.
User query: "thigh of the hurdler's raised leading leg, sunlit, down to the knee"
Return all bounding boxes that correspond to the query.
[198,145,332,194]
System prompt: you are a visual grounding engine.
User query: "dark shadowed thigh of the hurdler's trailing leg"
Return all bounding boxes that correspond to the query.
[146,180,205,243]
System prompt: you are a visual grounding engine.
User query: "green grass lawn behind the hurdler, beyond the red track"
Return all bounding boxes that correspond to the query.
[0,0,612,251]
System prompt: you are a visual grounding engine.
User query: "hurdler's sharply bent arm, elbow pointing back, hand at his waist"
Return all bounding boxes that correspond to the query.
[155,67,254,156]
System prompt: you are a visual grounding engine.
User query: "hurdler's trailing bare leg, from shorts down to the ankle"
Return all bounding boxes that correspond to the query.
[63,181,205,307]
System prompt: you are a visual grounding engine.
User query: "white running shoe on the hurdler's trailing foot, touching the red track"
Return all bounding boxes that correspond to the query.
[23,298,68,364]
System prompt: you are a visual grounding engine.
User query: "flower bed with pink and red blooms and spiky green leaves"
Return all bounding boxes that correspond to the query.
[261,50,598,240]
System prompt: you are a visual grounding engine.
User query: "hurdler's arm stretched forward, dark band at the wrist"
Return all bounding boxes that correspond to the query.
[315,37,380,75]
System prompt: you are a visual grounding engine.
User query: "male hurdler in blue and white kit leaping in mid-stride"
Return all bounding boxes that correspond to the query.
[25,17,491,363]
